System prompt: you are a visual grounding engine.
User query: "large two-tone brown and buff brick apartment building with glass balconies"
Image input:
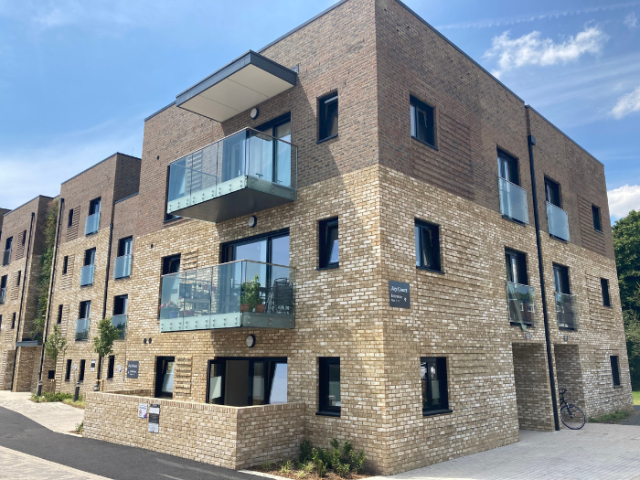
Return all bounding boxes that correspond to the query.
[0,0,632,474]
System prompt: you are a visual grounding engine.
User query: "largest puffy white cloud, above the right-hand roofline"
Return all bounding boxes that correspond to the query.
[484,25,609,77]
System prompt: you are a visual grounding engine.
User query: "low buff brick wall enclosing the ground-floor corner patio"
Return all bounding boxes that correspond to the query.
[84,392,304,469]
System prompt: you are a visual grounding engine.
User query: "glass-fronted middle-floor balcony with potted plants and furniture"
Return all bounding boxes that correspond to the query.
[160,260,295,332]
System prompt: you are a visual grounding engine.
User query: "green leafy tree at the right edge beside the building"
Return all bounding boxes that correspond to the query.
[613,210,640,390]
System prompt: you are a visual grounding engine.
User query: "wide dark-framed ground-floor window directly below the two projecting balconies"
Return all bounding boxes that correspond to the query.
[207,358,287,407]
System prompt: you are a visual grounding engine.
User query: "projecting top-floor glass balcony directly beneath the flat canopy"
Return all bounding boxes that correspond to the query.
[167,128,298,222]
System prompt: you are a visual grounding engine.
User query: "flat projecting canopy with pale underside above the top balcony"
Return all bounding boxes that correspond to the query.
[176,51,298,122]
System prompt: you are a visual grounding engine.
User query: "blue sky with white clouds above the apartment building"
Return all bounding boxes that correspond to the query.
[0,0,640,221]
